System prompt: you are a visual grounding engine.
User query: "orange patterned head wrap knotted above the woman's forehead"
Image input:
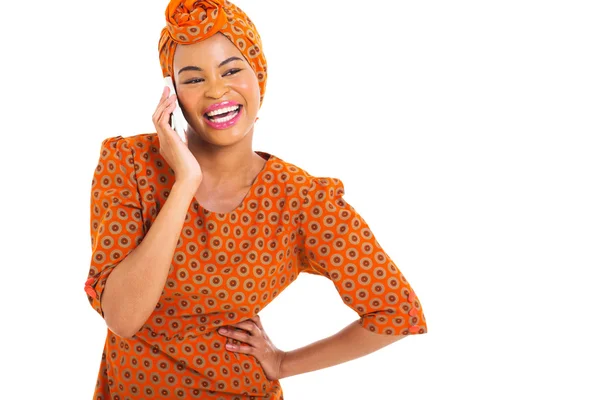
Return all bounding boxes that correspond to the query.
[158,0,267,105]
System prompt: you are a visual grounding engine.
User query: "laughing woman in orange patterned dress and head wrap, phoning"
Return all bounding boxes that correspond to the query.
[85,0,427,399]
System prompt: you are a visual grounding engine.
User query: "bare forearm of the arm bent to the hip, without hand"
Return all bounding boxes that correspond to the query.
[280,320,406,379]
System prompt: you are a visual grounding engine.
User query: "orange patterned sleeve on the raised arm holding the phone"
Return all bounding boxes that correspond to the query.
[84,136,144,318]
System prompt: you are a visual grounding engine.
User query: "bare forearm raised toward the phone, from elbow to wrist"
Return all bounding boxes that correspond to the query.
[101,182,198,337]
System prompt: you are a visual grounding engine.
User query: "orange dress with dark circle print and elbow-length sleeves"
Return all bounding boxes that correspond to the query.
[85,134,427,400]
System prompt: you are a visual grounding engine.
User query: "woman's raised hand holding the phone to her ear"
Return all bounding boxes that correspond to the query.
[152,86,202,185]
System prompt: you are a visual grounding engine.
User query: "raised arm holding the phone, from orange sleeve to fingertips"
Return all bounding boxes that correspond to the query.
[85,91,202,338]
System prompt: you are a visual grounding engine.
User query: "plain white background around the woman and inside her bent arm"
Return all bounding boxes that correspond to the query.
[0,0,600,400]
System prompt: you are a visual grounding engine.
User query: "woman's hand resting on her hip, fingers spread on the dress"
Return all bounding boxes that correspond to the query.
[218,315,285,380]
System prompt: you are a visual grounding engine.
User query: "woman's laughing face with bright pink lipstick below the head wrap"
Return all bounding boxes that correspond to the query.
[173,33,260,145]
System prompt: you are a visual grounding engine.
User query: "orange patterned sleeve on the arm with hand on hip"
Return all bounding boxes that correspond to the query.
[299,177,427,335]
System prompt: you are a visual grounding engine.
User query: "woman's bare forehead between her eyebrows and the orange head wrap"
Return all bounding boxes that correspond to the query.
[173,32,244,67]
